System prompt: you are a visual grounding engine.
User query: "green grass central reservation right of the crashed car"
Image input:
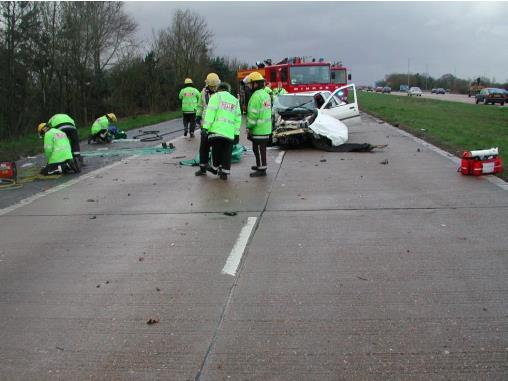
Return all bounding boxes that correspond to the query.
[358,92,508,180]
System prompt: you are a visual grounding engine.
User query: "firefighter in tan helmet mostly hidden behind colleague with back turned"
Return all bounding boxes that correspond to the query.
[194,73,220,176]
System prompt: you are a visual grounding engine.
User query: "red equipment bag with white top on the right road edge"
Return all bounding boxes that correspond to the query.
[459,148,503,176]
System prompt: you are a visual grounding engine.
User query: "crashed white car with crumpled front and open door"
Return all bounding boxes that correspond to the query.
[272,84,360,150]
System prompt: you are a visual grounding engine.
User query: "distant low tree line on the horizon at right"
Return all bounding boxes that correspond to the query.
[376,73,508,94]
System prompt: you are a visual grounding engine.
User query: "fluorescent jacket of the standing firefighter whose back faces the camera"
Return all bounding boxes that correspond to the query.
[203,91,242,140]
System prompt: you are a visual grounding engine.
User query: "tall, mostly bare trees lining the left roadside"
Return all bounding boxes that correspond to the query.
[0,1,245,139]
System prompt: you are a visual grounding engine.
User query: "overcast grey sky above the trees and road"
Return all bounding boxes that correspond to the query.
[125,2,508,85]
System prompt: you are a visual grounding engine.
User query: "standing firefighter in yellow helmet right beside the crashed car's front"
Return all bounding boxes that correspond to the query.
[247,72,272,177]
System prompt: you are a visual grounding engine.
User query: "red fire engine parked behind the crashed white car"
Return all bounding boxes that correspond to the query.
[237,57,351,110]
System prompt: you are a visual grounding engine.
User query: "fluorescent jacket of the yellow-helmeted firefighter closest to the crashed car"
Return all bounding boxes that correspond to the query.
[247,89,272,135]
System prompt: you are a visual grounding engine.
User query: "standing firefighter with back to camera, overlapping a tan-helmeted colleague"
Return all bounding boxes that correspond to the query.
[203,83,242,180]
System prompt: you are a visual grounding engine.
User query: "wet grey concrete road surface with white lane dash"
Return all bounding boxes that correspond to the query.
[0,115,508,381]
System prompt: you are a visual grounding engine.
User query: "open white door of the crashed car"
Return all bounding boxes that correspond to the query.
[320,84,360,125]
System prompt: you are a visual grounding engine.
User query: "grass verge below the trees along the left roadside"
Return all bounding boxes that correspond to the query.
[0,111,182,161]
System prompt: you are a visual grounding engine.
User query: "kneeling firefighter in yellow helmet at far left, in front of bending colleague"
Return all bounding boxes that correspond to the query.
[37,123,79,176]
